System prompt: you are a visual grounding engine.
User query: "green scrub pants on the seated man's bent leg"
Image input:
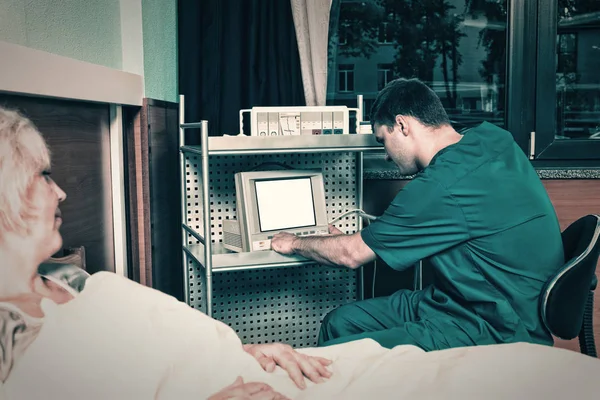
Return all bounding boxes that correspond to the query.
[319,290,482,351]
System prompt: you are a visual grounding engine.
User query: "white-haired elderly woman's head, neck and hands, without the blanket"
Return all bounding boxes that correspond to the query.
[0,108,330,399]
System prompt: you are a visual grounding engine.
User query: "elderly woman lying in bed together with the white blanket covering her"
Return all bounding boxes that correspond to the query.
[0,109,600,400]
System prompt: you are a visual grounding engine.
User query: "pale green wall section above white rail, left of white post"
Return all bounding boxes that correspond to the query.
[0,0,122,69]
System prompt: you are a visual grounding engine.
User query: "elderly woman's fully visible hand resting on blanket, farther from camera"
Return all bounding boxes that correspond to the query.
[244,343,331,389]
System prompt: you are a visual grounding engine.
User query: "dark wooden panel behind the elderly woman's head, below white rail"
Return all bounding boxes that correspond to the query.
[0,94,115,273]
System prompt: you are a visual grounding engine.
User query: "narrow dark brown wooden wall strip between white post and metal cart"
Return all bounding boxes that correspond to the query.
[127,99,183,300]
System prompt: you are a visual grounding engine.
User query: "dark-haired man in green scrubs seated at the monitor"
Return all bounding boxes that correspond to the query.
[272,79,564,351]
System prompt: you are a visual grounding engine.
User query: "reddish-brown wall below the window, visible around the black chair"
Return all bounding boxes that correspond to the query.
[543,179,600,351]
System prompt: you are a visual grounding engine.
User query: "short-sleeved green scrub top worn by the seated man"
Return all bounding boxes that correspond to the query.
[361,122,564,348]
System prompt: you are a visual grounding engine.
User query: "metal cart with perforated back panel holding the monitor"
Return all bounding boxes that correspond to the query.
[179,96,381,347]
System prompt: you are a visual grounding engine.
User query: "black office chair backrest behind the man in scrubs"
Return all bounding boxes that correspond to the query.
[540,215,600,357]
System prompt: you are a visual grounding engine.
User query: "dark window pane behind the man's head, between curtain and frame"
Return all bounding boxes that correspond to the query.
[328,0,508,129]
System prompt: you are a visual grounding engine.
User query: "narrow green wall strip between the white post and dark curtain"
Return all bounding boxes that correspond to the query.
[142,0,179,102]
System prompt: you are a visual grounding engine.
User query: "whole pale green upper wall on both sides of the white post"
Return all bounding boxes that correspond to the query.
[0,0,178,102]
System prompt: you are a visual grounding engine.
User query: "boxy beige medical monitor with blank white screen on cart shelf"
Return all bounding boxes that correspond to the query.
[223,170,328,252]
